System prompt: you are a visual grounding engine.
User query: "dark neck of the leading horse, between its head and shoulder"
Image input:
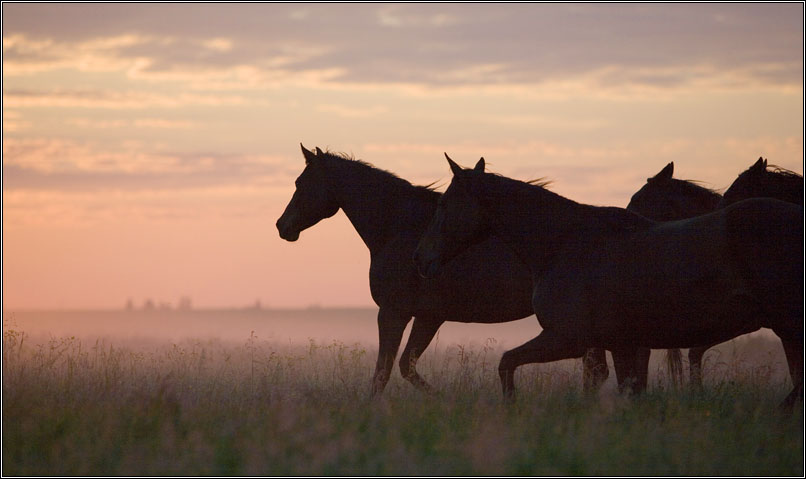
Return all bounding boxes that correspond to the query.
[331,160,436,254]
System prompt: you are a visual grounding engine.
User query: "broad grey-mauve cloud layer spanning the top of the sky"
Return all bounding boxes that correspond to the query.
[3,4,803,90]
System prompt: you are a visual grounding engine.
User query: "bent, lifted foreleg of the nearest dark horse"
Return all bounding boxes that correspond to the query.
[498,330,586,400]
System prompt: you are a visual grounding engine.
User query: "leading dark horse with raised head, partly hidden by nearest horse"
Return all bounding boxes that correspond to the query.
[277,144,620,396]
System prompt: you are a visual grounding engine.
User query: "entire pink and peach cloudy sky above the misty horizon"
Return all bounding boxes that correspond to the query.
[3,3,804,310]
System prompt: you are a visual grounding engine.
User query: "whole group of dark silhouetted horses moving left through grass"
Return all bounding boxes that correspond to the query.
[277,145,804,409]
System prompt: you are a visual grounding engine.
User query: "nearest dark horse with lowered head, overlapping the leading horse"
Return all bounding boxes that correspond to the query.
[414,154,803,408]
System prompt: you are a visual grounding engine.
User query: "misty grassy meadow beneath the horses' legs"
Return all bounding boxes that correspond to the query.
[2,312,804,476]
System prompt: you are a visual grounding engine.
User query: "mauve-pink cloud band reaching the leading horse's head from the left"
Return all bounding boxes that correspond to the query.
[3,138,297,191]
